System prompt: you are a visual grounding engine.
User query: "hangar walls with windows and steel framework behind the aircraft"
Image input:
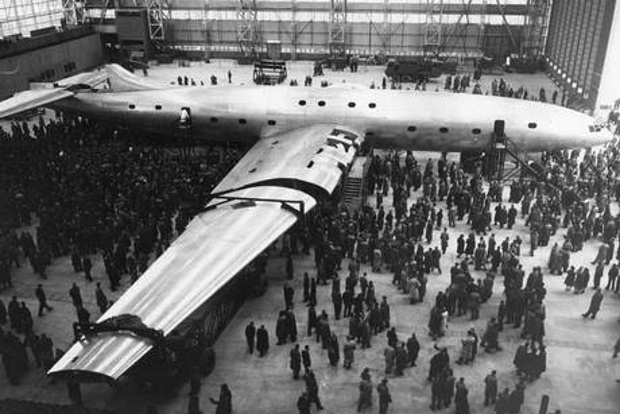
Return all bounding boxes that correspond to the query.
[0,0,615,110]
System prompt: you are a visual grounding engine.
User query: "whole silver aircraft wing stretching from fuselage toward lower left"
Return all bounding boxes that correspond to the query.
[49,125,362,379]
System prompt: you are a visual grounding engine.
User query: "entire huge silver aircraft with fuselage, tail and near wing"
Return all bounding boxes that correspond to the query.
[0,65,612,380]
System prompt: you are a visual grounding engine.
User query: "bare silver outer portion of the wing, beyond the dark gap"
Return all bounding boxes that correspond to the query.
[49,187,314,379]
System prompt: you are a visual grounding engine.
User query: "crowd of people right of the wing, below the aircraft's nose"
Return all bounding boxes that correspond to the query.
[229,124,620,414]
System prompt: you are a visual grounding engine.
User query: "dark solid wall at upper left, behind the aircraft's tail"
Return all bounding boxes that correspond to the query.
[0,27,103,99]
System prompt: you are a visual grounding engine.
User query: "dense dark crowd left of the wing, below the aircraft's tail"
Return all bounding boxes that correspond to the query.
[0,114,241,408]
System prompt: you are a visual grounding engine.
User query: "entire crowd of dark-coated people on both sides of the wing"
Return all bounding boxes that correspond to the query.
[0,67,620,414]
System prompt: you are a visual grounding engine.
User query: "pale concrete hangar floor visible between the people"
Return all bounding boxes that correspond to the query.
[0,61,620,414]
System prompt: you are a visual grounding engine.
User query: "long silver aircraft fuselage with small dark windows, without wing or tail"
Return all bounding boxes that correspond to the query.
[53,86,611,152]
